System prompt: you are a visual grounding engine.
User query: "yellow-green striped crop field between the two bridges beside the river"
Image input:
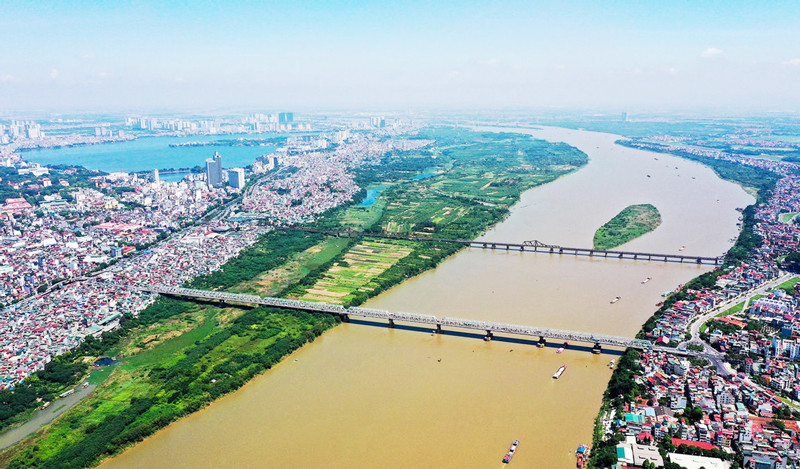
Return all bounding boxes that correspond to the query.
[300,241,412,304]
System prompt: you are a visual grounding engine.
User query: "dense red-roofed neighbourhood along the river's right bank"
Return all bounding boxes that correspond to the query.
[592,140,800,469]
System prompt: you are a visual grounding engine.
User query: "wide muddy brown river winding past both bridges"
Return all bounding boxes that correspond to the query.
[97,128,753,469]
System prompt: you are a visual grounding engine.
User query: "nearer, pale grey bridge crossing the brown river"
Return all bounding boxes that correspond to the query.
[138,285,664,355]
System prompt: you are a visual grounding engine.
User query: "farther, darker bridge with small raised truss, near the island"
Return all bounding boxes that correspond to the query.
[275,227,724,265]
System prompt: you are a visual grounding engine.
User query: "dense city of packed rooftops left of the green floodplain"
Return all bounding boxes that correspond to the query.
[0,118,430,388]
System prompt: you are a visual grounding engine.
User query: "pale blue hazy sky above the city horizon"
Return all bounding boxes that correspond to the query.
[0,0,800,112]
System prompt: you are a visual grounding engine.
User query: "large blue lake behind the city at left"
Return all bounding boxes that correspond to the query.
[21,133,277,172]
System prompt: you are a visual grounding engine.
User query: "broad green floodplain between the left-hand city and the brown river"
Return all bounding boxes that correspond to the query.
[0,128,587,468]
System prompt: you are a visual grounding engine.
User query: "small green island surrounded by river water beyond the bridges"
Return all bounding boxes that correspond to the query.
[594,204,661,250]
